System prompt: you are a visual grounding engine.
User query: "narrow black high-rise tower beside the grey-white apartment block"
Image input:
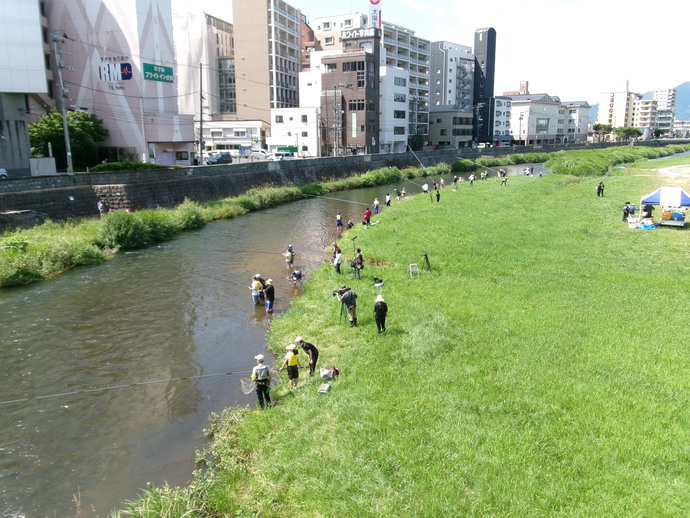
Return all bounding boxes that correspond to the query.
[473,27,496,142]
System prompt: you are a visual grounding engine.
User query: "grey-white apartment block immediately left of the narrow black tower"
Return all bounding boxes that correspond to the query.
[429,41,475,148]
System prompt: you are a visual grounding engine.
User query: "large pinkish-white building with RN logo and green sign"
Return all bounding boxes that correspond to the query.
[46,0,194,165]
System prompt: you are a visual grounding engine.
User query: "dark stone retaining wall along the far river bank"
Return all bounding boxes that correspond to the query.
[0,141,687,230]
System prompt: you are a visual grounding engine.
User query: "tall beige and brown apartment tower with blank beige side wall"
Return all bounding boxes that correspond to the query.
[232,0,302,121]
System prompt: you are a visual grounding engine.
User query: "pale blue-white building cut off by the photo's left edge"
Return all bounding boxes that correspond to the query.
[0,0,52,177]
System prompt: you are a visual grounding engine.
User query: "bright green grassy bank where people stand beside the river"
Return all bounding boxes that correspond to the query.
[122,161,690,517]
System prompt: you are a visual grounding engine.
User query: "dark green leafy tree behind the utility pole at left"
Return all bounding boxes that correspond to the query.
[29,110,108,169]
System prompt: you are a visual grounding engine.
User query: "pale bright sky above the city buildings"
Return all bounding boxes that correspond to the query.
[173,0,690,104]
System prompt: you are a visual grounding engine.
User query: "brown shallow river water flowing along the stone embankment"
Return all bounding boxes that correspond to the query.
[0,166,536,518]
